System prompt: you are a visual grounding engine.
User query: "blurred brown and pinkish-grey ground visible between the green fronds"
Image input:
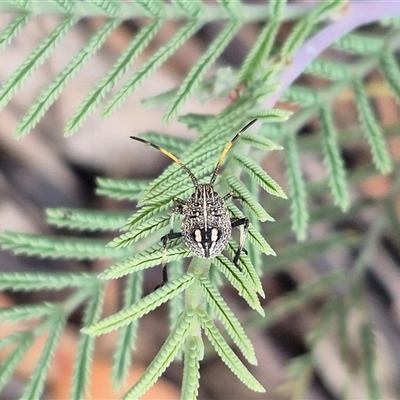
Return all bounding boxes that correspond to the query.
[0,6,400,400]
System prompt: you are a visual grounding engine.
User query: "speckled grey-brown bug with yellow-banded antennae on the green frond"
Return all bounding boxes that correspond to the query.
[130,119,257,286]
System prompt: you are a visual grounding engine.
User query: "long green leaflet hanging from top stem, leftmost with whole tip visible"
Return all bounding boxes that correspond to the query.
[16,19,120,137]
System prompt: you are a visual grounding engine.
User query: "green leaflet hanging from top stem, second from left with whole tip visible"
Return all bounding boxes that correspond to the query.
[65,19,163,136]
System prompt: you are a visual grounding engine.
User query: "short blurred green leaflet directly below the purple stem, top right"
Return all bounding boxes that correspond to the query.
[333,32,384,55]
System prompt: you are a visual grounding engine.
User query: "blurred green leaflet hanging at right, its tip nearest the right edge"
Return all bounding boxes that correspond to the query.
[354,79,393,174]
